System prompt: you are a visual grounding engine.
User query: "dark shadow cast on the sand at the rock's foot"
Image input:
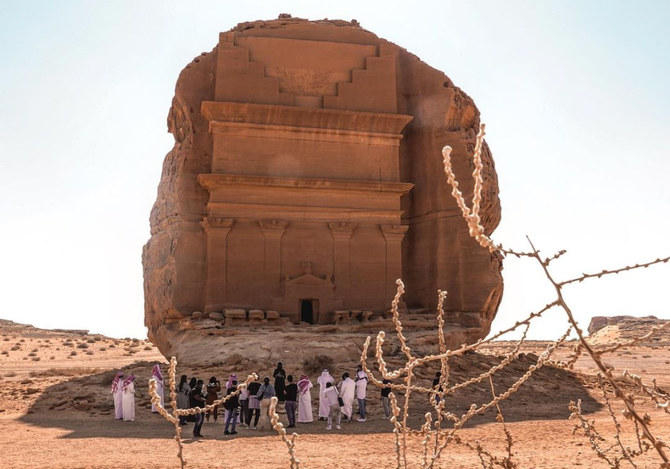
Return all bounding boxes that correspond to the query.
[21,353,602,440]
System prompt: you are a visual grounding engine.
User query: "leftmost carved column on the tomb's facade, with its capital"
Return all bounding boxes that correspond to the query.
[201,217,235,312]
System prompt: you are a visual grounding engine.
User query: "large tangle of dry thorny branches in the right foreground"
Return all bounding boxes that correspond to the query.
[361,124,670,469]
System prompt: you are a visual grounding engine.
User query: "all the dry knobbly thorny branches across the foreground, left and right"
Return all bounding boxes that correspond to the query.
[150,124,670,469]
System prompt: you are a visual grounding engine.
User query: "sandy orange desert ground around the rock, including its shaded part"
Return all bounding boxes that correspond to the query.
[0,321,670,469]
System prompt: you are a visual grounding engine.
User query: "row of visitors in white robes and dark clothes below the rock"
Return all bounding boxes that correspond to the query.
[112,362,400,437]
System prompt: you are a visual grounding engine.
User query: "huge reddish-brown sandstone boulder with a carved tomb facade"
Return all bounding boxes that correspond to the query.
[143,16,503,359]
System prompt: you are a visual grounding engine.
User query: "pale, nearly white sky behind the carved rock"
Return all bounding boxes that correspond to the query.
[0,1,670,337]
